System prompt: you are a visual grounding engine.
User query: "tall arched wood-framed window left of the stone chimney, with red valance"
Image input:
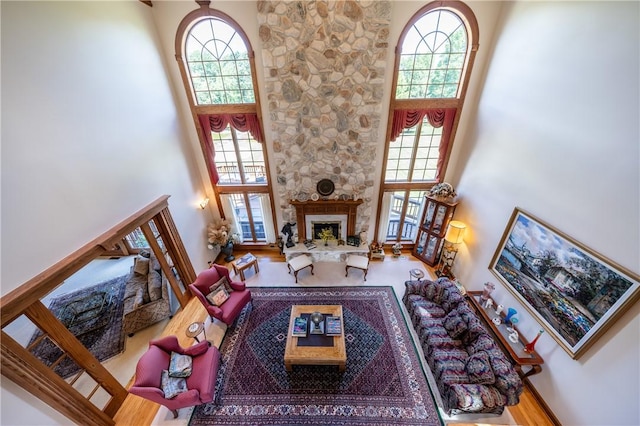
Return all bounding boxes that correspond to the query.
[176,6,276,243]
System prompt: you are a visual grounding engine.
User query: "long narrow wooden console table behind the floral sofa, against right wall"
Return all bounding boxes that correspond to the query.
[467,291,544,377]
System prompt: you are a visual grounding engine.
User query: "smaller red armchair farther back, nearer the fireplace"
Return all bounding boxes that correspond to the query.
[189,264,251,325]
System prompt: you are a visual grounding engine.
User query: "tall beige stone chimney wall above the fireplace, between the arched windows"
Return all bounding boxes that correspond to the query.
[258,0,391,231]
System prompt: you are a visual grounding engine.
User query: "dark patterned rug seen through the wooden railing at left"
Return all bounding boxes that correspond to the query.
[28,275,128,378]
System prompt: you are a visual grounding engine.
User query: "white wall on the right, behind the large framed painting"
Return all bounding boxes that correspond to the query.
[456,2,640,425]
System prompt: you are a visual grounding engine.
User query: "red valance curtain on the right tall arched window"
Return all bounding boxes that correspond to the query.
[391,108,456,179]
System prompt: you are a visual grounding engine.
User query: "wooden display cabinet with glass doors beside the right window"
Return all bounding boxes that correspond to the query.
[413,195,458,266]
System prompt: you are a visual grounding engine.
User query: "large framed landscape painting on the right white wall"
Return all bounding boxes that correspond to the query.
[489,208,640,359]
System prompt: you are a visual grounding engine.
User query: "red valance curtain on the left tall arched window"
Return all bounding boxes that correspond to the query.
[198,113,264,185]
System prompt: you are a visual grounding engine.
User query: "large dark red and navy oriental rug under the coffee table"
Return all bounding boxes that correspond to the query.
[189,286,443,426]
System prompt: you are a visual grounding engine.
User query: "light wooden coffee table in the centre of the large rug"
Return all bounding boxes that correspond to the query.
[284,305,347,371]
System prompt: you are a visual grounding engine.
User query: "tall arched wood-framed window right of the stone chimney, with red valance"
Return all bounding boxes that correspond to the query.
[377,2,478,242]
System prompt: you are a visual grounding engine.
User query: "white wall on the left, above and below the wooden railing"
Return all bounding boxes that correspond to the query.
[0,1,208,425]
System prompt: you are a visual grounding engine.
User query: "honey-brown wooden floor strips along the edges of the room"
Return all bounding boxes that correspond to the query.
[114,251,559,426]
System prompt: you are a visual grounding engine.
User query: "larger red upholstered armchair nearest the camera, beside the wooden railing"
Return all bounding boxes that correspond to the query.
[129,336,220,417]
